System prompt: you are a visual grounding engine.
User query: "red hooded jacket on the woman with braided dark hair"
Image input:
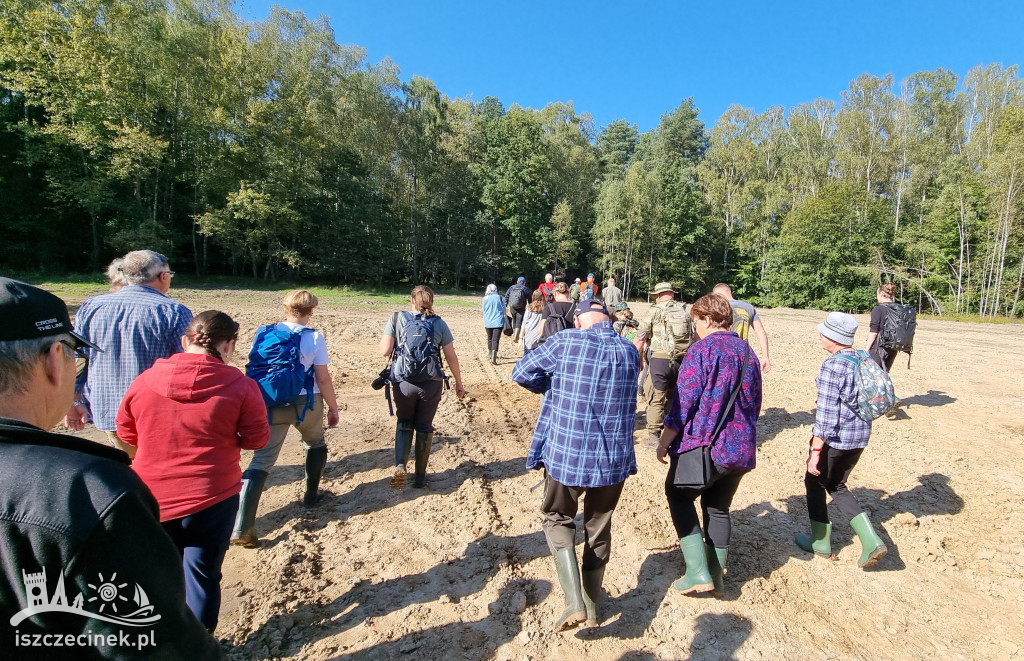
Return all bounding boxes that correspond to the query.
[117,353,270,521]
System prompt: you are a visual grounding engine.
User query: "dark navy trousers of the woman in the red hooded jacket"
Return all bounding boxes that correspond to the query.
[162,494,239,631]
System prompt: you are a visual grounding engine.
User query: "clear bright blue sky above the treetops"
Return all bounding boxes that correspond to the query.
[241,0,1024,131]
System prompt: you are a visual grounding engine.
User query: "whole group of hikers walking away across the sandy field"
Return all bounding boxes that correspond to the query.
[0,251,908,658]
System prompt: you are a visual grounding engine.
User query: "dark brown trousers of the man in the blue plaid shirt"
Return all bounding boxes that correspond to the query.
[541,475,626,571]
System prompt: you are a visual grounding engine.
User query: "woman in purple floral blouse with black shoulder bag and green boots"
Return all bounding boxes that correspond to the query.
[657,294,761,594]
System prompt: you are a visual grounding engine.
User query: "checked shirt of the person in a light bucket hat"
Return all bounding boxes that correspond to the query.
[814,354,871,450]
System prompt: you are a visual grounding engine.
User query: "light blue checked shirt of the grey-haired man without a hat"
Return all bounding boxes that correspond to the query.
[75,285,191,432]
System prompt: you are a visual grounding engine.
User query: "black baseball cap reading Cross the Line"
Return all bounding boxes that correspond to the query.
[0,277,102,351]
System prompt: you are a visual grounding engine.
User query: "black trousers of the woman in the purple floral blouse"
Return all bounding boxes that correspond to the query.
[665,454,745,548]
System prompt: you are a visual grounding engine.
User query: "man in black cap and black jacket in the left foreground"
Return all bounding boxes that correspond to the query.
[0,277,222,659]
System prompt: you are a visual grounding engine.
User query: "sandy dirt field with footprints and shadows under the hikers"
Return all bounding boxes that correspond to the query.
[69,290,1024,659]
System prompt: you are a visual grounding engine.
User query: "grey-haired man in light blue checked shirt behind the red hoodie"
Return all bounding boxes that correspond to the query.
[66,250,193,456]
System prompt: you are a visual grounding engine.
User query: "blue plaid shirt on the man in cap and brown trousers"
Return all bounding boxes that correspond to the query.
[512,321,640,487]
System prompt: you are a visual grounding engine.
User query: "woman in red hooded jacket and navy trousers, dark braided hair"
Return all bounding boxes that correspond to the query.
[117,310,270,632]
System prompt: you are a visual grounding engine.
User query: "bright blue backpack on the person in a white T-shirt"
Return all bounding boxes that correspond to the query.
[246,324,313,423]
